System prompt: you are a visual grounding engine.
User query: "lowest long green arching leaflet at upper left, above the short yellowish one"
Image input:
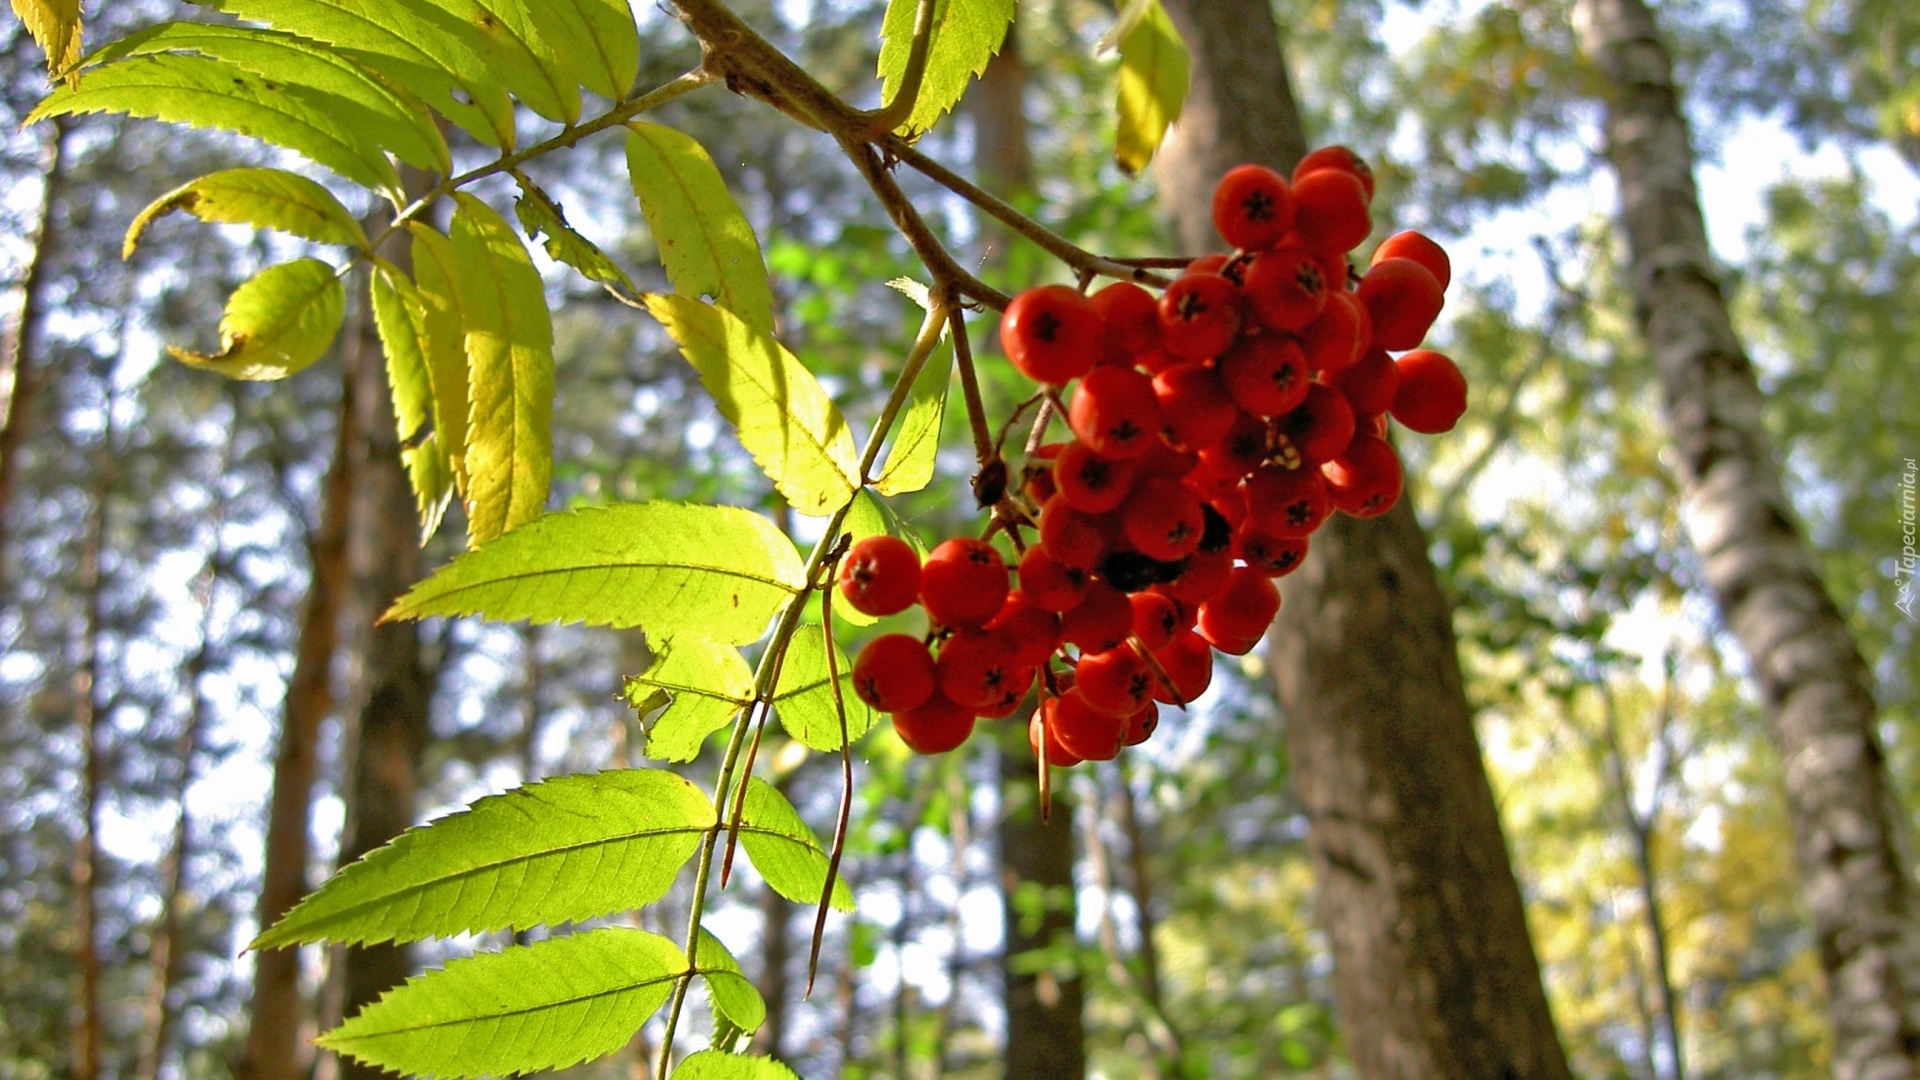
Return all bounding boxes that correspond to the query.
[27,52,399,192]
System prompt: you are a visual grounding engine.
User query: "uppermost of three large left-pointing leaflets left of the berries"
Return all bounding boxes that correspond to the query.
[386,502,806,646]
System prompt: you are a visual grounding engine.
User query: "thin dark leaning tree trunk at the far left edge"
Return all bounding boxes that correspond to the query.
[0,119,69,590]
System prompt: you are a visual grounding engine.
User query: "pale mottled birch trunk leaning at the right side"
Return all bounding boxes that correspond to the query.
[1574,0,1920,1080]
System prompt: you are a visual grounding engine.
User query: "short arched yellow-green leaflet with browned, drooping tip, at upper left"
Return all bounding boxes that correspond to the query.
[121,169,367,259]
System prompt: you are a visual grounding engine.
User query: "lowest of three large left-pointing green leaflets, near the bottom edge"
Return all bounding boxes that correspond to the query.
[319,926,687,1078]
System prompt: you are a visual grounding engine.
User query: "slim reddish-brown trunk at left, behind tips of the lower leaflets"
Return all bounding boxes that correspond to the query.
[234,369,361,1080]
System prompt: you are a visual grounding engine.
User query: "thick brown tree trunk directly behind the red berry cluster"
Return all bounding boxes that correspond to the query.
[1160,0,1571,1080]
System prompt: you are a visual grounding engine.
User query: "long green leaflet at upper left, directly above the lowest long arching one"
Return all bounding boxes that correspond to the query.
[86,23,453,173]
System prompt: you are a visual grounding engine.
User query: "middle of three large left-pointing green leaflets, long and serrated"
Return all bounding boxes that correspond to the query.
[252,769,716,949]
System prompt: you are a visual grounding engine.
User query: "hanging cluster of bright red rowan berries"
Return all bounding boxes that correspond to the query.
[839,146,1467,765]
